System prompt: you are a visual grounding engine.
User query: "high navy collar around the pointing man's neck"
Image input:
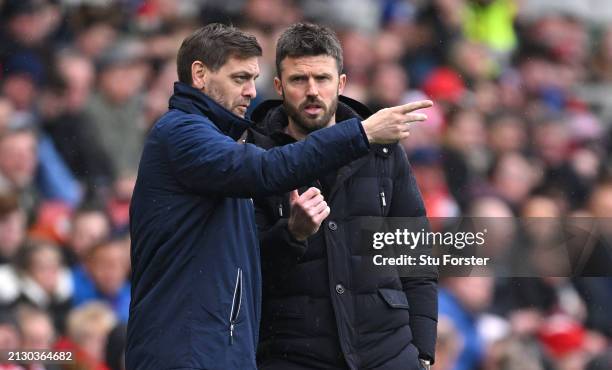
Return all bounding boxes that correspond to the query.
[170,81,253,140]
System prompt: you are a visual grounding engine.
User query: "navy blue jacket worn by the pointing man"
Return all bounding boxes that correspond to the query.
[126,83,369,370]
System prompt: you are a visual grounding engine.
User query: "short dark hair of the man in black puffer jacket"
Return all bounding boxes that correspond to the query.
[276,23,343,77]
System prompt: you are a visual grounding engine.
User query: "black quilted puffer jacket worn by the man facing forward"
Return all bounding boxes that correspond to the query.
[249,97,437,369]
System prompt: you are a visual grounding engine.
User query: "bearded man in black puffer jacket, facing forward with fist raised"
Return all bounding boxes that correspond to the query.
[248,24,437,370]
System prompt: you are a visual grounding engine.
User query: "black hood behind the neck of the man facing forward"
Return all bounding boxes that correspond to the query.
[251,95,372,136]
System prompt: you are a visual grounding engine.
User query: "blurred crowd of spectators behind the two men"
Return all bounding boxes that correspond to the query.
[0,0,612,370]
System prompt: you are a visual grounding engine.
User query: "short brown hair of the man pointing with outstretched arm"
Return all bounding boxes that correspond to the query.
[176,23,262,84]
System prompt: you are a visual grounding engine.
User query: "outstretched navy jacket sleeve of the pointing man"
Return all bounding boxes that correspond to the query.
[165,118,369,198]
